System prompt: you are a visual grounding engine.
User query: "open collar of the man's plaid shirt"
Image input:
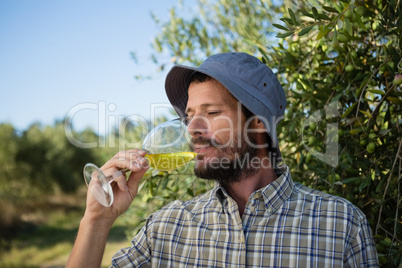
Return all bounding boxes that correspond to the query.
[214,165,294,213]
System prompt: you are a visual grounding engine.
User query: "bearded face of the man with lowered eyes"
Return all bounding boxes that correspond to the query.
[186,79,255,185]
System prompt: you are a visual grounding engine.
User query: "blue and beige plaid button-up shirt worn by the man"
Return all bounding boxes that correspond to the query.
[111,167,378,267]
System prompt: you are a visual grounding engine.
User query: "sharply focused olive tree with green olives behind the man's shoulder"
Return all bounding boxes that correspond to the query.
[267,1,402,267]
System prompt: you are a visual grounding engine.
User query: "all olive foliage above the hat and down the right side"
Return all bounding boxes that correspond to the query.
[141,0,402,267]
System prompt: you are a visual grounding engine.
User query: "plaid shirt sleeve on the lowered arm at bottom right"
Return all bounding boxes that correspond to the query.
[345,218,379,267]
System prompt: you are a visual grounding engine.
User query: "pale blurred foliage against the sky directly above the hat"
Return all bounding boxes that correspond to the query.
[149,0,289,66]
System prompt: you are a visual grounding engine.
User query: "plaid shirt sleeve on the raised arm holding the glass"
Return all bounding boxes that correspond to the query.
[109,215,152,268]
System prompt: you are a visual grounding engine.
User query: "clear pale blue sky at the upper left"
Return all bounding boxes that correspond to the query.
[0,0,190,132]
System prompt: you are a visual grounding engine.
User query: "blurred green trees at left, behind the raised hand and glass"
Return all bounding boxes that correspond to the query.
[0,115,204,240]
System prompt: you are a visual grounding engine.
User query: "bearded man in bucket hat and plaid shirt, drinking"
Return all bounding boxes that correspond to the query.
[68,53,378,267]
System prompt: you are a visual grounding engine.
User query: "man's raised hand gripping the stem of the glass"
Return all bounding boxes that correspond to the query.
[84,149,149,226]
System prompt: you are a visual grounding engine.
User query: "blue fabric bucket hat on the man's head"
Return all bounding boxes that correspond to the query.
[165,52,286,157]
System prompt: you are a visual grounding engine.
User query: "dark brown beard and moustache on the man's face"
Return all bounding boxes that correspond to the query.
[191,133,258,187]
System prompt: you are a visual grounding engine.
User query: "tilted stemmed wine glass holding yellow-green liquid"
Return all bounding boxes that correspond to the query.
[84,118,197,207]
